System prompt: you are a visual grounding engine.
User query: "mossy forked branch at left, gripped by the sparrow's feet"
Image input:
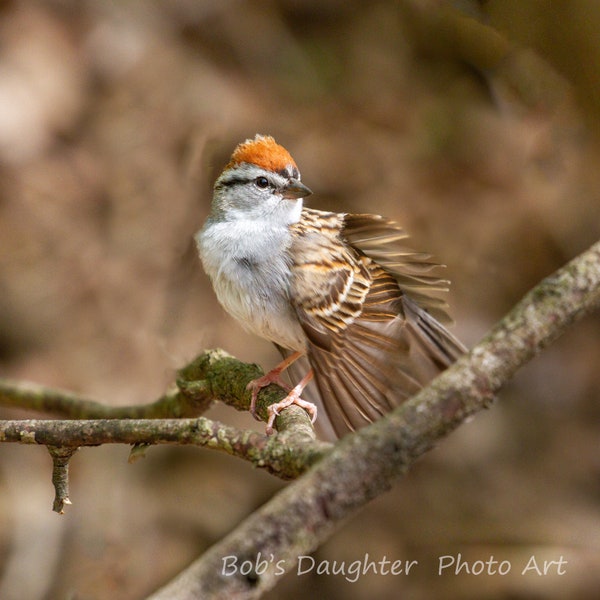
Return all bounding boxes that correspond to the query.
[0,350,331,500]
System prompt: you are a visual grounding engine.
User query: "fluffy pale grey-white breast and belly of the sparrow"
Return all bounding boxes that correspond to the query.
[196,220,306,350]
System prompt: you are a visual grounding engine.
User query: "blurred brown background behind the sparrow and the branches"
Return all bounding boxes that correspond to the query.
[0,0,600,600]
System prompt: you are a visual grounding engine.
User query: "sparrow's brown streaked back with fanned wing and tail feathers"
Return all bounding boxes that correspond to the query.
[291,209,464,436]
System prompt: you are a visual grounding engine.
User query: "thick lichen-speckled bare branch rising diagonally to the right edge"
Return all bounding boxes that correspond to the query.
[145,243,600,600]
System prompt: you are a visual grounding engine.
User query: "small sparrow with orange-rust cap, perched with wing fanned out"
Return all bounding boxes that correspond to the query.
[196,135,465,436]
